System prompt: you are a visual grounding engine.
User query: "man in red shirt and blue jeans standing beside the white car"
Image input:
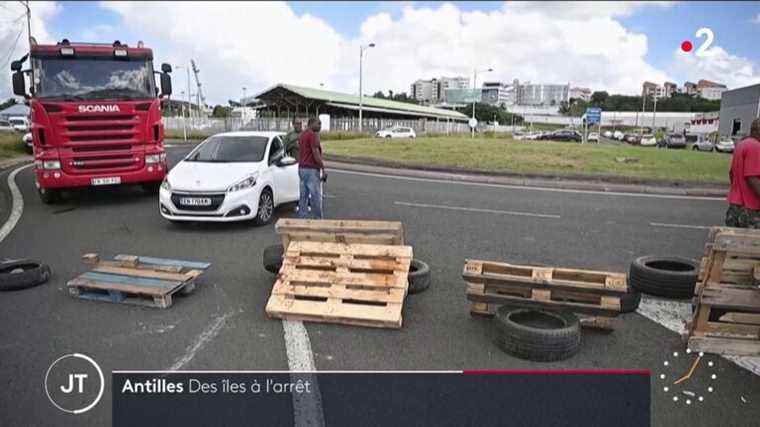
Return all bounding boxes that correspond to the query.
[298,117,327,219]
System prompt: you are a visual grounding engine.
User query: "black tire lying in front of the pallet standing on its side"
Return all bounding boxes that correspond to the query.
[494,306,581,362]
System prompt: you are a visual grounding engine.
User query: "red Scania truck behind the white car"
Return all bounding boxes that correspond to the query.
[11,39,172,203]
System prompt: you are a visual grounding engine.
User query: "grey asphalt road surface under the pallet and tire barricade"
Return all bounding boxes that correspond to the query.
[0,142,760,426]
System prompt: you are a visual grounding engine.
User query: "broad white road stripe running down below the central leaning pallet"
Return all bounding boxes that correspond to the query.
[282,320,325,427]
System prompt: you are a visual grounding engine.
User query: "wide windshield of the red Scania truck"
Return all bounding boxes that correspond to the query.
[35,58,155,100]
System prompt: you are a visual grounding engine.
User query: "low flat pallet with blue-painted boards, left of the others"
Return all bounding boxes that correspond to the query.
[66,254,210,308]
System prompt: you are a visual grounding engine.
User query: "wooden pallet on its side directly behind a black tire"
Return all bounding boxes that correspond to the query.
[462,260,628,317]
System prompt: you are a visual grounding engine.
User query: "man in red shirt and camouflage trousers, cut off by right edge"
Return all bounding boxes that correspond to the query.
[726,118,760,228]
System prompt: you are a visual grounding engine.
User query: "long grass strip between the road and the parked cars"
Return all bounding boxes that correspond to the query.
[323,137,731,183]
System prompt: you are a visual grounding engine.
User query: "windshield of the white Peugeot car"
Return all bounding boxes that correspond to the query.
[185,136,269,163]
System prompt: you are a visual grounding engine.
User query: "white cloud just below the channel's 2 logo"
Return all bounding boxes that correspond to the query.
[673,46,760,89]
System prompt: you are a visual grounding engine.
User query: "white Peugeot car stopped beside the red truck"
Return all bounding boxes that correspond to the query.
[159,132,299,225]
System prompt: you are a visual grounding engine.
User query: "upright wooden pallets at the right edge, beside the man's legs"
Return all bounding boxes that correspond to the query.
[687,227,760,356]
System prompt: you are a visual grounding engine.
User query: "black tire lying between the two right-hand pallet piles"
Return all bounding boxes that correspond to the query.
[628,255,698,299]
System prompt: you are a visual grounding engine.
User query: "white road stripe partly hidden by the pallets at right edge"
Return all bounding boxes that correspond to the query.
[636,295,760,376]
